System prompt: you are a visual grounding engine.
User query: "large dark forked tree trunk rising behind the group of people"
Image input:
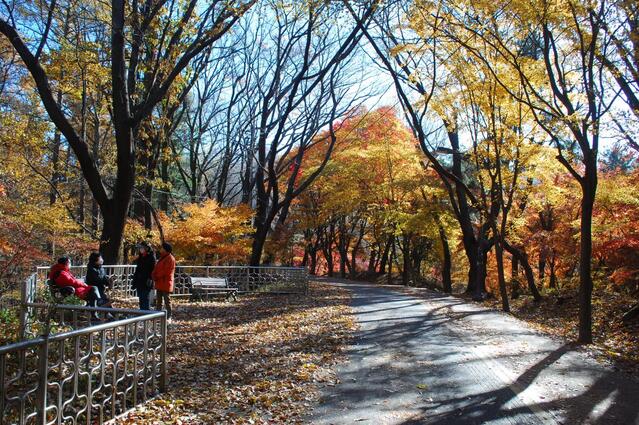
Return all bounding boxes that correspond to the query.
[0,0,255,262]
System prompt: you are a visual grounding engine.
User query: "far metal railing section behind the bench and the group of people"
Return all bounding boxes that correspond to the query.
[33,265,308,302]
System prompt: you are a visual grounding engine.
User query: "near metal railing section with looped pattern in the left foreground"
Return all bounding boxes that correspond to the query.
[0,303,167,425]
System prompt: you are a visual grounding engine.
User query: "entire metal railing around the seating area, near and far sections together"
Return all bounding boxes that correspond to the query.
[0,265,308,425]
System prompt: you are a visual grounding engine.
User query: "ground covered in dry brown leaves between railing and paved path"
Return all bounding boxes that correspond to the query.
[119,283,355,424]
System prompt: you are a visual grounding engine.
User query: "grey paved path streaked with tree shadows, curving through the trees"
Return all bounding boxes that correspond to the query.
[308,282,639,425]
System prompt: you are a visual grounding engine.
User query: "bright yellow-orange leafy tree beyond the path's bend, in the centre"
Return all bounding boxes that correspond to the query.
[291,107,455,291]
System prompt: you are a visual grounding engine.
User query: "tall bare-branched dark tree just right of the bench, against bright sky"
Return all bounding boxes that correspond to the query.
[239,2,380,265]
